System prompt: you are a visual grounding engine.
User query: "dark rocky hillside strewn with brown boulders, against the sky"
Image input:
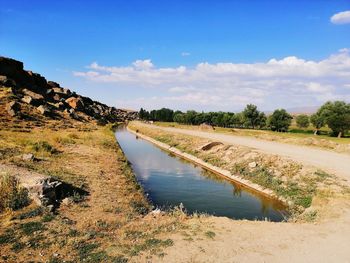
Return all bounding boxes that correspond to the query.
[0,57,137,128]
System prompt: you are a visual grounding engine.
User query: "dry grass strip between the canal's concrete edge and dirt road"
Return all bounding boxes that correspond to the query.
[129,122,349,221]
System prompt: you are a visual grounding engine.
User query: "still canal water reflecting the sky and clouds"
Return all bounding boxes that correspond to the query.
[116,127,286,222]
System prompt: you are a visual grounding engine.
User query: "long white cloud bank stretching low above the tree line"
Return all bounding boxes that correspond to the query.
[74,49,350,110]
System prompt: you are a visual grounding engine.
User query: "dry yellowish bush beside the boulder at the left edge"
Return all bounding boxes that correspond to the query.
[0,174,29,212]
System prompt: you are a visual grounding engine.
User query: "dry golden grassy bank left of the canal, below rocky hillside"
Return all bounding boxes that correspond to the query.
[0,124,212,262]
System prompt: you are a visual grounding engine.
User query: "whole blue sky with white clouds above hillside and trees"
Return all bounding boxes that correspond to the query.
[0,0,350,111]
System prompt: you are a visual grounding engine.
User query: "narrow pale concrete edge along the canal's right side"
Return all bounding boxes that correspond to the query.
[126,126,289,206]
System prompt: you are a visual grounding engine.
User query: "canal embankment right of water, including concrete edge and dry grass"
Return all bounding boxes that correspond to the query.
[128,122,347,219]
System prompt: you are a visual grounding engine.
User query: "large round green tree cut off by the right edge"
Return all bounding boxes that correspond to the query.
[317,101,350,137]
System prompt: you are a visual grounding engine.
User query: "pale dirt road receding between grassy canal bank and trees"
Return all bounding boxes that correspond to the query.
[142,124,350,182]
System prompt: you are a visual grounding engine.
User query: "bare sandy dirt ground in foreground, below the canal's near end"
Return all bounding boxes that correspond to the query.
[161,200,350,263]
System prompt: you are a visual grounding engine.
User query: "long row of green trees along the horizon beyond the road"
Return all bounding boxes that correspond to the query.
[139,101,350,137]
